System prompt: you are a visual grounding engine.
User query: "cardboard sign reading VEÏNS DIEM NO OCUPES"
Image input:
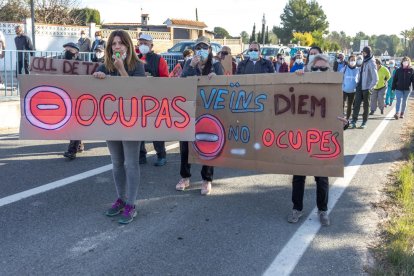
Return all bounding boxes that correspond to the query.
[190,72,344,176]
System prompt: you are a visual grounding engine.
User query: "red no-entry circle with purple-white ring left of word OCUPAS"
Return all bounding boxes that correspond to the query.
[24,86,72,130]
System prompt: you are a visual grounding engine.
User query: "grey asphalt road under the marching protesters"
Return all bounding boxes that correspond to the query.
[0,100,410,275]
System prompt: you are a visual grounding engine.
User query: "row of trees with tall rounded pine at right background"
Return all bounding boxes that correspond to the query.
[236,0,414,57]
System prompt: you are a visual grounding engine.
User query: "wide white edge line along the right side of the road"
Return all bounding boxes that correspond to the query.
[263,109,395,276]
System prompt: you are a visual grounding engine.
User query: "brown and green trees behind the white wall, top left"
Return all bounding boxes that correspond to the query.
[0,0,101,25]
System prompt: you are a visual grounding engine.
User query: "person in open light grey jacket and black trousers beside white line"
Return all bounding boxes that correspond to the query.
[350,46,378,129]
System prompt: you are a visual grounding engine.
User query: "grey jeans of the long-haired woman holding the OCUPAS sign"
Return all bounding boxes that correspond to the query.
[106,141,141,205]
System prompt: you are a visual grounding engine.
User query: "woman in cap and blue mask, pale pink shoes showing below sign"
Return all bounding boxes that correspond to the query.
[175,36,224,195]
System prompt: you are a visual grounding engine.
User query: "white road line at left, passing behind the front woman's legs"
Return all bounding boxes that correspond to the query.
[0,143,179,207]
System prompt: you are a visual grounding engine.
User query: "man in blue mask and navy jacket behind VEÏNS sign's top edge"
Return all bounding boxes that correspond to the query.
[236,41,275,75]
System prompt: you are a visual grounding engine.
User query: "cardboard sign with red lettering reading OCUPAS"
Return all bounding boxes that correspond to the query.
[20,75,197,141]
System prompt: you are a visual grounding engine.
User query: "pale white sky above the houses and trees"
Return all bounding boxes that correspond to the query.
[79,0,414,36]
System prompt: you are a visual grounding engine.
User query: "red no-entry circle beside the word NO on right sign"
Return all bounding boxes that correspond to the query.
[193,114,226,160]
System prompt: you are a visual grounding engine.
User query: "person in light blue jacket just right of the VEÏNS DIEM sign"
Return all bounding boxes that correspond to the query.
[341,55,359,120]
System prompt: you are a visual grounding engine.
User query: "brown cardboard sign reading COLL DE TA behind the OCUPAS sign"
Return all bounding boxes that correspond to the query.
[30,57,100,75]
